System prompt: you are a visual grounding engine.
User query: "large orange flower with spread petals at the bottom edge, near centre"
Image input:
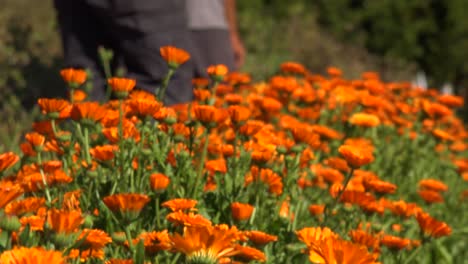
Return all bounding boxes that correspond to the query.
[170,226,239,263]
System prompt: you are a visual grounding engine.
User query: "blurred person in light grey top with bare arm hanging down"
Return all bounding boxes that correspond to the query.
[186,0,246,77]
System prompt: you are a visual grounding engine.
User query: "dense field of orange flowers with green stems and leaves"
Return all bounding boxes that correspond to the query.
[0,47,468,264]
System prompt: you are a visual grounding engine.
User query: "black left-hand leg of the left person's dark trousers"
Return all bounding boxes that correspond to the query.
[54,0,109,100]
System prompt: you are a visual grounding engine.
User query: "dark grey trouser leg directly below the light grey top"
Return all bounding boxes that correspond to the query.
[190,29,237,77]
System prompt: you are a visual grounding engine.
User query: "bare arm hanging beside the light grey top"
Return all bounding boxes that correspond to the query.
[224,0,246,68]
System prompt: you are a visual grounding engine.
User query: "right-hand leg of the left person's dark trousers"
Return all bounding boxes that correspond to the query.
[101,0,193,105]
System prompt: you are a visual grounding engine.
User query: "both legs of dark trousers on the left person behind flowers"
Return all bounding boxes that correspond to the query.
[55,0,194,105]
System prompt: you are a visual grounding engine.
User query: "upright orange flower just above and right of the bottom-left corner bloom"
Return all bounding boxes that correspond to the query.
[47,208,84,234]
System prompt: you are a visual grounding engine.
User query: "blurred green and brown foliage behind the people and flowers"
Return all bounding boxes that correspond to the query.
[0,0,468,150]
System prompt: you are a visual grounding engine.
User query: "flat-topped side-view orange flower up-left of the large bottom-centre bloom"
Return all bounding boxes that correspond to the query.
[102,193,150,214]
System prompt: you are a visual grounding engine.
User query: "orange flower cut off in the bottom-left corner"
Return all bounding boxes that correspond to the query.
[0,247,66,264]
